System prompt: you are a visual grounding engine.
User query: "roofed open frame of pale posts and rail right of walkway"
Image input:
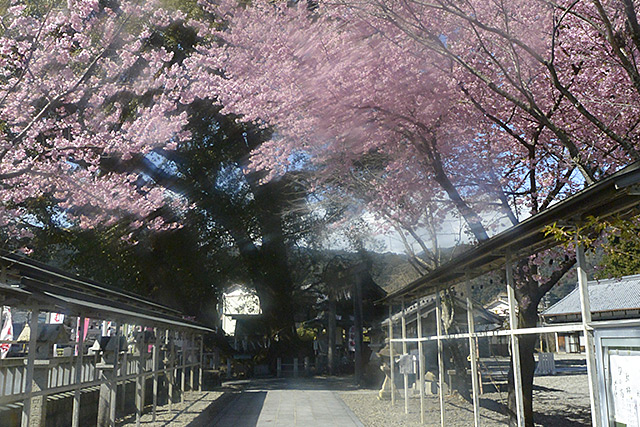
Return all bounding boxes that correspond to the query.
[381,163,640,427]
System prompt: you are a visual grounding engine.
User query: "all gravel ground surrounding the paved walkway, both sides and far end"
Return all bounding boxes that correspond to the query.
[118,356,591,427]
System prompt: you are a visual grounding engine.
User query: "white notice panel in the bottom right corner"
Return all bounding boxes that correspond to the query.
[609,354,640,427]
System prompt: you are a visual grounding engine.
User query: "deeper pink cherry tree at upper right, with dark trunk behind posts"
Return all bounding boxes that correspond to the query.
[336,0,640,425]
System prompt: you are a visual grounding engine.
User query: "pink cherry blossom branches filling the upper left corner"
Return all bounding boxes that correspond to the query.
[0,0,186,237]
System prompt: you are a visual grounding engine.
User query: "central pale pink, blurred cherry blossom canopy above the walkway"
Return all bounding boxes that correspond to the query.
[189,3,508,247]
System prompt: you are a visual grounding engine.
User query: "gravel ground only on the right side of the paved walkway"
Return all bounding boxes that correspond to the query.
[340,374,591,427]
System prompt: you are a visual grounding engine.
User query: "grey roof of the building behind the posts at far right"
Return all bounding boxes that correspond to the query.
[542,274,640,317]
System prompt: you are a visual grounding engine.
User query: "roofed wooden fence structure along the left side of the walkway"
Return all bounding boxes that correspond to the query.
[0,251,213,427]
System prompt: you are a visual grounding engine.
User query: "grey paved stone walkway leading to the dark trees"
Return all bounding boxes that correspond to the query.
[213,379,363,427]
